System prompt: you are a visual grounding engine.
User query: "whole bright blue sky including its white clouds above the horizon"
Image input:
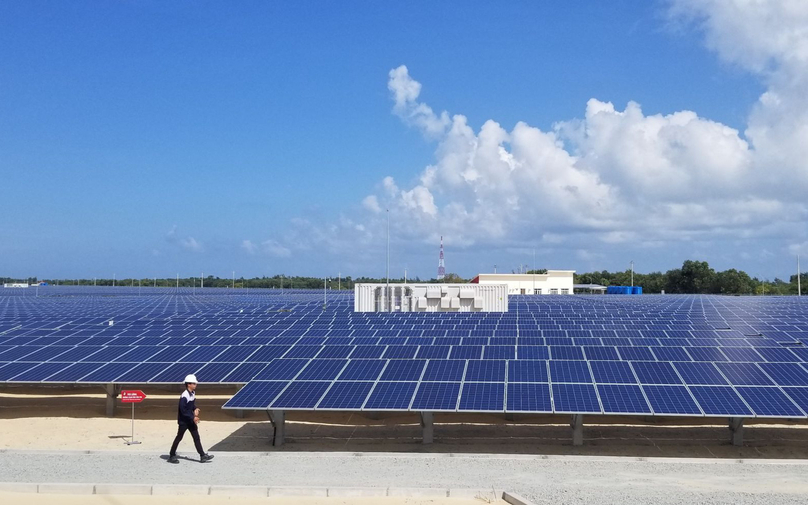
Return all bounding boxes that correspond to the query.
[0,0,808,278]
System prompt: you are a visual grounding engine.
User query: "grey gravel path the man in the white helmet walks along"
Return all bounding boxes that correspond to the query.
[0,451,808,505]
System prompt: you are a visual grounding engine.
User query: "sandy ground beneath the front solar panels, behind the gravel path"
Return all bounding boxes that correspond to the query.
[0,385,808,456]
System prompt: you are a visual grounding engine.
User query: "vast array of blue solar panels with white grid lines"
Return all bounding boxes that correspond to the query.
[0,287,808,418]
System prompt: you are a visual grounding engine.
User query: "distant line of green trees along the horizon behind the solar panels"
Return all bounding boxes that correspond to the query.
[0,260,808,295]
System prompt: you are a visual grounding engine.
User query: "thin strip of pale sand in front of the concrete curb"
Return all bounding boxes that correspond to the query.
[0,492,492,505]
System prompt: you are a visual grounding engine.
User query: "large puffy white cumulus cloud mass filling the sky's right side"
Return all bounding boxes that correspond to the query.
[252,0,808,270]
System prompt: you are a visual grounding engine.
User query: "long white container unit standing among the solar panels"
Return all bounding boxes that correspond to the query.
[354,284,508,312]
